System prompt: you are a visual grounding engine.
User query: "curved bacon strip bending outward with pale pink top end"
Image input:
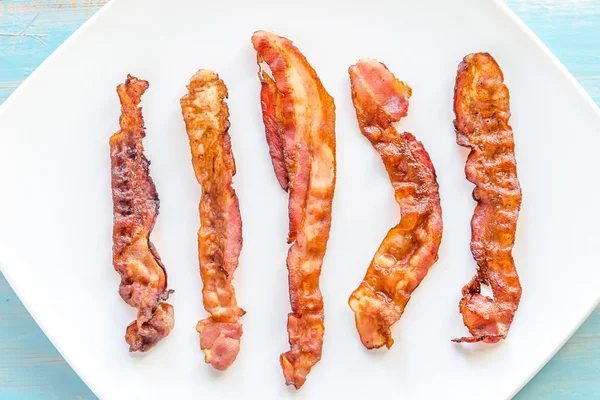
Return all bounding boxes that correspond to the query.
[348,59,442,349]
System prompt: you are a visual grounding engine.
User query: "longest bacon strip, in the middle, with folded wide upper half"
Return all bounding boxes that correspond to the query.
[252,31,336,389]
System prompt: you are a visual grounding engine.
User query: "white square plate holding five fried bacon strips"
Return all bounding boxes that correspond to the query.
[0,0,600,400]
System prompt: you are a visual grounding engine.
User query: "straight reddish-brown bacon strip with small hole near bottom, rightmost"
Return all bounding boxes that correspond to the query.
[454,53,521,343]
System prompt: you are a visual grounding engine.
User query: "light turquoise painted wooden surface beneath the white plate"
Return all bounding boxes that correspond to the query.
[0,0,600,400]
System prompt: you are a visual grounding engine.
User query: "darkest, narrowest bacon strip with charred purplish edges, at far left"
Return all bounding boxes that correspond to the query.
[110,75,174,351]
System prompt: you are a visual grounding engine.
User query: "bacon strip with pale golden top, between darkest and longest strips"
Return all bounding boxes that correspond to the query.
[181,69,245,371]
